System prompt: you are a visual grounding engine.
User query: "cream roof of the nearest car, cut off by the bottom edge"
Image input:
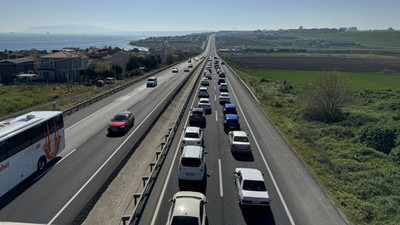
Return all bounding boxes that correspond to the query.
[173,191,206,217]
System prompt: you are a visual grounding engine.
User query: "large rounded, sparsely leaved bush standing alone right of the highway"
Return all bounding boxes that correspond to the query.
[299,71,356,122]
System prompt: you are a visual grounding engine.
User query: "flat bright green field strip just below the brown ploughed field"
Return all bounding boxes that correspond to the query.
[244,69,400,90]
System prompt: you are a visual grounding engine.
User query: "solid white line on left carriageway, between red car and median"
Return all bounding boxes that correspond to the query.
[48,71,189,225]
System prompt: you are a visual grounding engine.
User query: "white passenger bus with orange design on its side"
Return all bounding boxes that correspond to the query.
[0,111,65,197]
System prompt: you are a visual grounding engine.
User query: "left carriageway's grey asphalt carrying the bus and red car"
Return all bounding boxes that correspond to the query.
[0,53,205,224]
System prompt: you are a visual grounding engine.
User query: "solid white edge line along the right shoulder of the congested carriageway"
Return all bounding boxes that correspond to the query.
[226,76,295,225]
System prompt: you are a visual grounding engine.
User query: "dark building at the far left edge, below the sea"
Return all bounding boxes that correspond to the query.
[0,58,34,84]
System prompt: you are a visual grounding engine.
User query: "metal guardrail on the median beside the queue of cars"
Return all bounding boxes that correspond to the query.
[122,55,206,225]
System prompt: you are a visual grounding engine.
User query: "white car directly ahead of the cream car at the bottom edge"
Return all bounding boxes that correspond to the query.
[178,145,206,181]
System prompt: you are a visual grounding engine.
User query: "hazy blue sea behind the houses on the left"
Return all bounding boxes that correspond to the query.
[0,33,146,52]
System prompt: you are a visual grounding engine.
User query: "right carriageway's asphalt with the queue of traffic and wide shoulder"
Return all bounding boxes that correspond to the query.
[137,36,347,225]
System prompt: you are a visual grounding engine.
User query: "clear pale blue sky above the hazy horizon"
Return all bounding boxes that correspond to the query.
[0,0,400,33]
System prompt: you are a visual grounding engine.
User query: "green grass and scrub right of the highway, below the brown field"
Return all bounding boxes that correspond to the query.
[225,64,400,224]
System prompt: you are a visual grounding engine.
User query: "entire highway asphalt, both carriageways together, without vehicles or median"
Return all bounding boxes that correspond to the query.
[0,36,347,225]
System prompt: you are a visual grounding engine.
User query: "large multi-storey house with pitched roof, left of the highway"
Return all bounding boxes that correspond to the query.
[38,51,88,82]
